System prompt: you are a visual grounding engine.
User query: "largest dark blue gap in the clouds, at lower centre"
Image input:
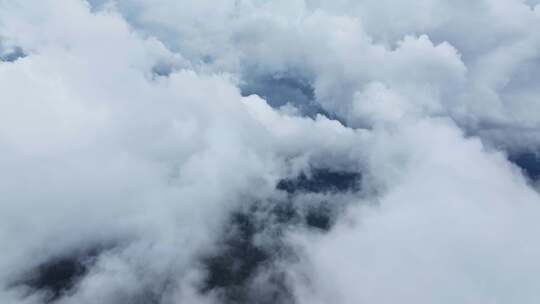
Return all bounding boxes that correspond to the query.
[200,168,361,304]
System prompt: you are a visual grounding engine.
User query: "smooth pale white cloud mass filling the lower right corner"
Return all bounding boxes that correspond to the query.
[293,121,540,303]
